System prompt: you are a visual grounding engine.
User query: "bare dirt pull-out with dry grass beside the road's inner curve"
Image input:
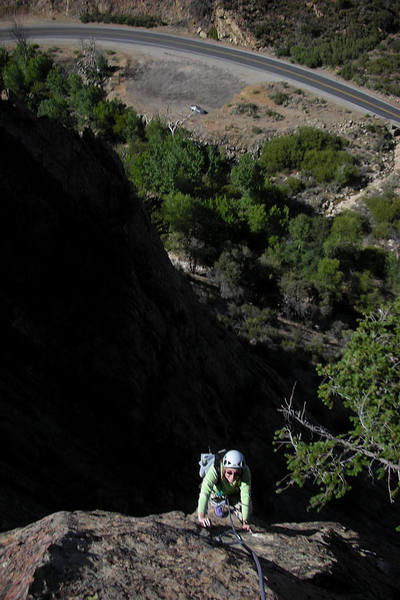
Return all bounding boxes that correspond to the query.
[94,39,364,150]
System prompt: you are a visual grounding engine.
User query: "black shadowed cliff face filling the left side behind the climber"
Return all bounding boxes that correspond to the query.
[0,102,288,529]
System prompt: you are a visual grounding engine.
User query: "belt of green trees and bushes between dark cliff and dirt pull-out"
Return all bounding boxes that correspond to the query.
[0,43,400,357]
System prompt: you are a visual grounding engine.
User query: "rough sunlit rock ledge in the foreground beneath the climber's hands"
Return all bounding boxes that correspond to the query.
[0,511,400,600]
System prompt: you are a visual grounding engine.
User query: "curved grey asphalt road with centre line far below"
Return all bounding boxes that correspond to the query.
[0,25,400,126]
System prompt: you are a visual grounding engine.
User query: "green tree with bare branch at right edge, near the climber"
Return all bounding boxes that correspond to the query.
[275,300,400,524]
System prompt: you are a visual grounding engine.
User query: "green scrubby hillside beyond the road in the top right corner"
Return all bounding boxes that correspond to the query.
[234,0,400,95]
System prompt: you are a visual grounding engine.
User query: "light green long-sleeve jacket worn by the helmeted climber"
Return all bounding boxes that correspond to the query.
[197,464,251,521]
